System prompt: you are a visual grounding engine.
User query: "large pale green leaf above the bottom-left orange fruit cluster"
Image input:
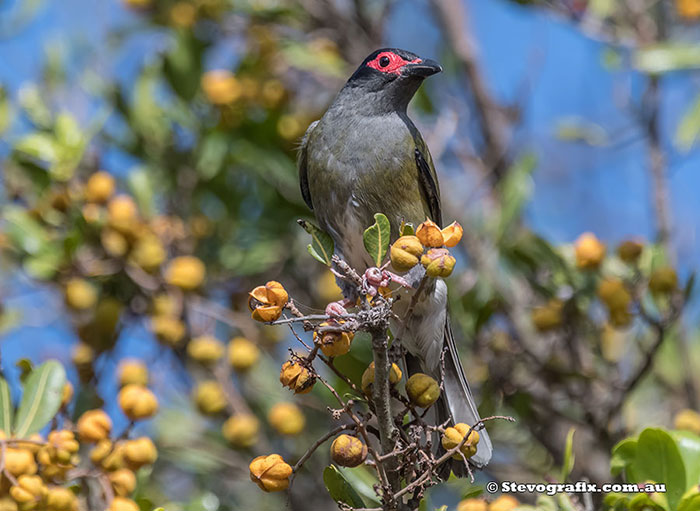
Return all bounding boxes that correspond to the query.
[14,360,66,438]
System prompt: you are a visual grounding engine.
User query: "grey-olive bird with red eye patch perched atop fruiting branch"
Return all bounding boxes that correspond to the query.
[297,48,493,475]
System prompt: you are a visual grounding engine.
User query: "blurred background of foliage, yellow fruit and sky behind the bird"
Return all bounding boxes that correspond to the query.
[0,0,700,511]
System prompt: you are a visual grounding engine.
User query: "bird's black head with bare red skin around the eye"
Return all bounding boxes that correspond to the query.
[345,48,442,109]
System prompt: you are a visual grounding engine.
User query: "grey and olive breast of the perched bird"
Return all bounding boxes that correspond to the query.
[307,116,425,269]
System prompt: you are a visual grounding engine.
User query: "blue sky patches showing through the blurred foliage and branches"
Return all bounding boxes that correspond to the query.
[0,0,700,424]
